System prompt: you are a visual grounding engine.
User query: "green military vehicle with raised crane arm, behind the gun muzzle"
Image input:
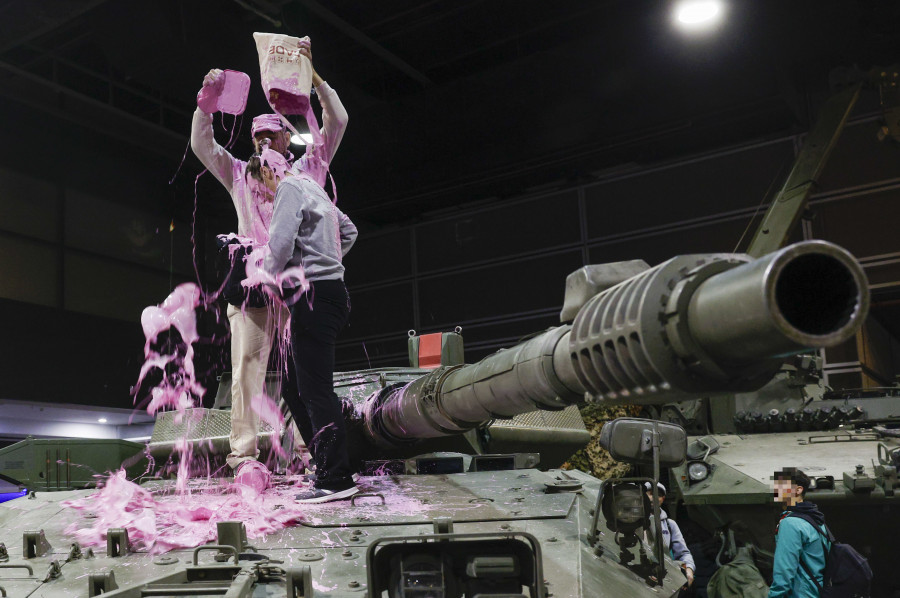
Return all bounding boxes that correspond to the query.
[644,65,900,597]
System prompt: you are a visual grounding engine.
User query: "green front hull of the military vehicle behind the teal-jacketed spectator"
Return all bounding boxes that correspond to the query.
[671,429,900,596]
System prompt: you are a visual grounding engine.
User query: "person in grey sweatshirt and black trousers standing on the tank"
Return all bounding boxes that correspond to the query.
[249,149,357,503]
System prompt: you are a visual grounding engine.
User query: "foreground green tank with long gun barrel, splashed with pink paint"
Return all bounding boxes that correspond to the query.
[0,242,868,598]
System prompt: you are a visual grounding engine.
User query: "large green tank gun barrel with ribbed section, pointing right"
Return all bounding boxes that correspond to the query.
[366,241,869,443]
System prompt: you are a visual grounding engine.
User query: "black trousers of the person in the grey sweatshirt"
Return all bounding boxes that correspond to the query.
[283,280,354,490]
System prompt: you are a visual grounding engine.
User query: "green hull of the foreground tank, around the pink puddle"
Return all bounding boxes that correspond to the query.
[0,469,683,598]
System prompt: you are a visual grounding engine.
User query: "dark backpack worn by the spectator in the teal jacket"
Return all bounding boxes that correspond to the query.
[790,513,873,598]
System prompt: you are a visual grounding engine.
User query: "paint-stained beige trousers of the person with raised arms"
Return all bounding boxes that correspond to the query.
[227,305,284,469]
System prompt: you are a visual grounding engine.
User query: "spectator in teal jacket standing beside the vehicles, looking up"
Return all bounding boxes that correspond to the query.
[769,467,830,598]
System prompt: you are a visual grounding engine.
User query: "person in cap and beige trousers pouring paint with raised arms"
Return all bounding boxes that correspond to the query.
[191,41,348,489]
